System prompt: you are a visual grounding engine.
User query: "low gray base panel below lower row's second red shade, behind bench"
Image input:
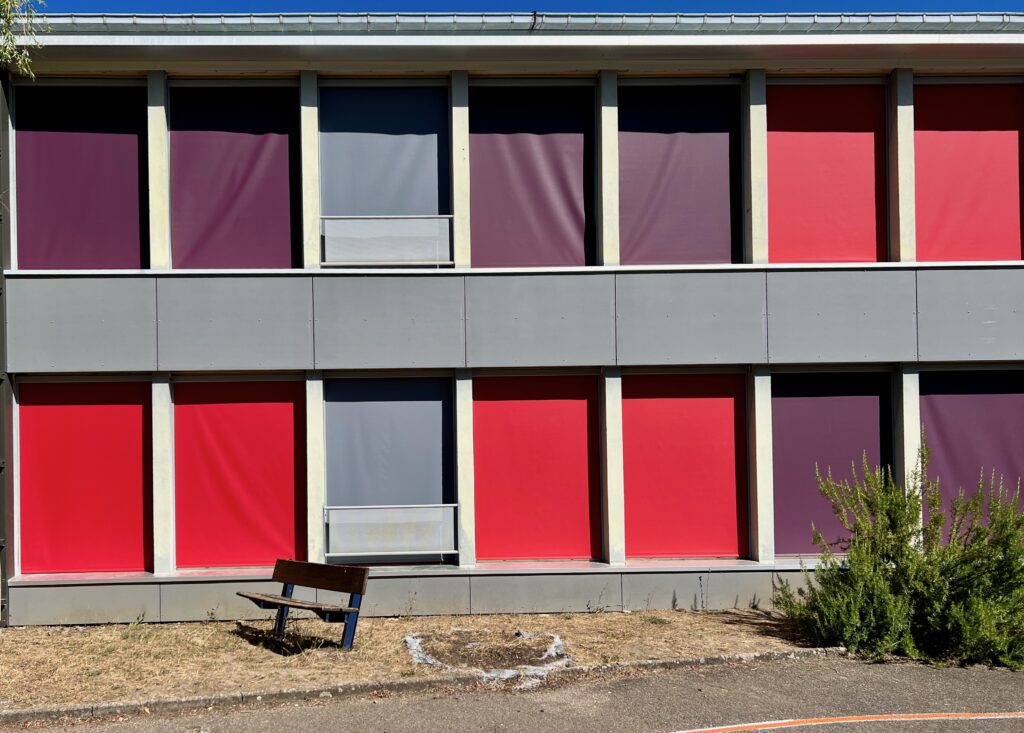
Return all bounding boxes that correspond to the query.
[160,580,316,621]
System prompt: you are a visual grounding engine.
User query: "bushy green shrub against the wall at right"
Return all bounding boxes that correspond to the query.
[776,448,1024,669]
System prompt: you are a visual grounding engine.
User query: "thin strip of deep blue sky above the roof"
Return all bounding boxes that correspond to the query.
[36,0,1024,13]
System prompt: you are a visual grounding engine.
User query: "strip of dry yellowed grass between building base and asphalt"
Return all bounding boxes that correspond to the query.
[0,611,800,709]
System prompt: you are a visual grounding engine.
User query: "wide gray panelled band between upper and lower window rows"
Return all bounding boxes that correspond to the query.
[5,266,1024,373]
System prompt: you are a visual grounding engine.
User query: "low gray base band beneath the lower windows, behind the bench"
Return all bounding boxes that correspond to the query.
[2,569,802,626]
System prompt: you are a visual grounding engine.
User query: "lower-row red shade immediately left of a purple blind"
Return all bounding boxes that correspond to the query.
[623,375,748,557]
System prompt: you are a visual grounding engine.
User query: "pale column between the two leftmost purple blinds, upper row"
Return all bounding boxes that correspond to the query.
[146,72,171,270]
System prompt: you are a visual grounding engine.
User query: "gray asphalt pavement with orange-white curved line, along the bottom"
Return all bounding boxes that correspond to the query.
[41,658,1024,733]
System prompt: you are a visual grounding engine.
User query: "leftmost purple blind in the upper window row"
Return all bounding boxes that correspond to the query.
[14,86,150,269]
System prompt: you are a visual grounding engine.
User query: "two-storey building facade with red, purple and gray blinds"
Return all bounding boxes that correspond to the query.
[0,13,1024,624]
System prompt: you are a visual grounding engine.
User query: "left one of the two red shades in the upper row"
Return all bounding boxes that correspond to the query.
[768,84,887,262]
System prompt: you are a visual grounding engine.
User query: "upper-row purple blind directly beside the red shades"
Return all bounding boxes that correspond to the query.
[618,86,742,264]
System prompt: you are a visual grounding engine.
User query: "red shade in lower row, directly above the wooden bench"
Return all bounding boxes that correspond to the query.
[174,382,306,567]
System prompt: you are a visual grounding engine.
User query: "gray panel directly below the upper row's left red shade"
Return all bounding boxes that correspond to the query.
[768,269,918,363]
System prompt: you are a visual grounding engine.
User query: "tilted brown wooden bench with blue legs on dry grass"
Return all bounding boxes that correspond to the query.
[239,560,370,649]
